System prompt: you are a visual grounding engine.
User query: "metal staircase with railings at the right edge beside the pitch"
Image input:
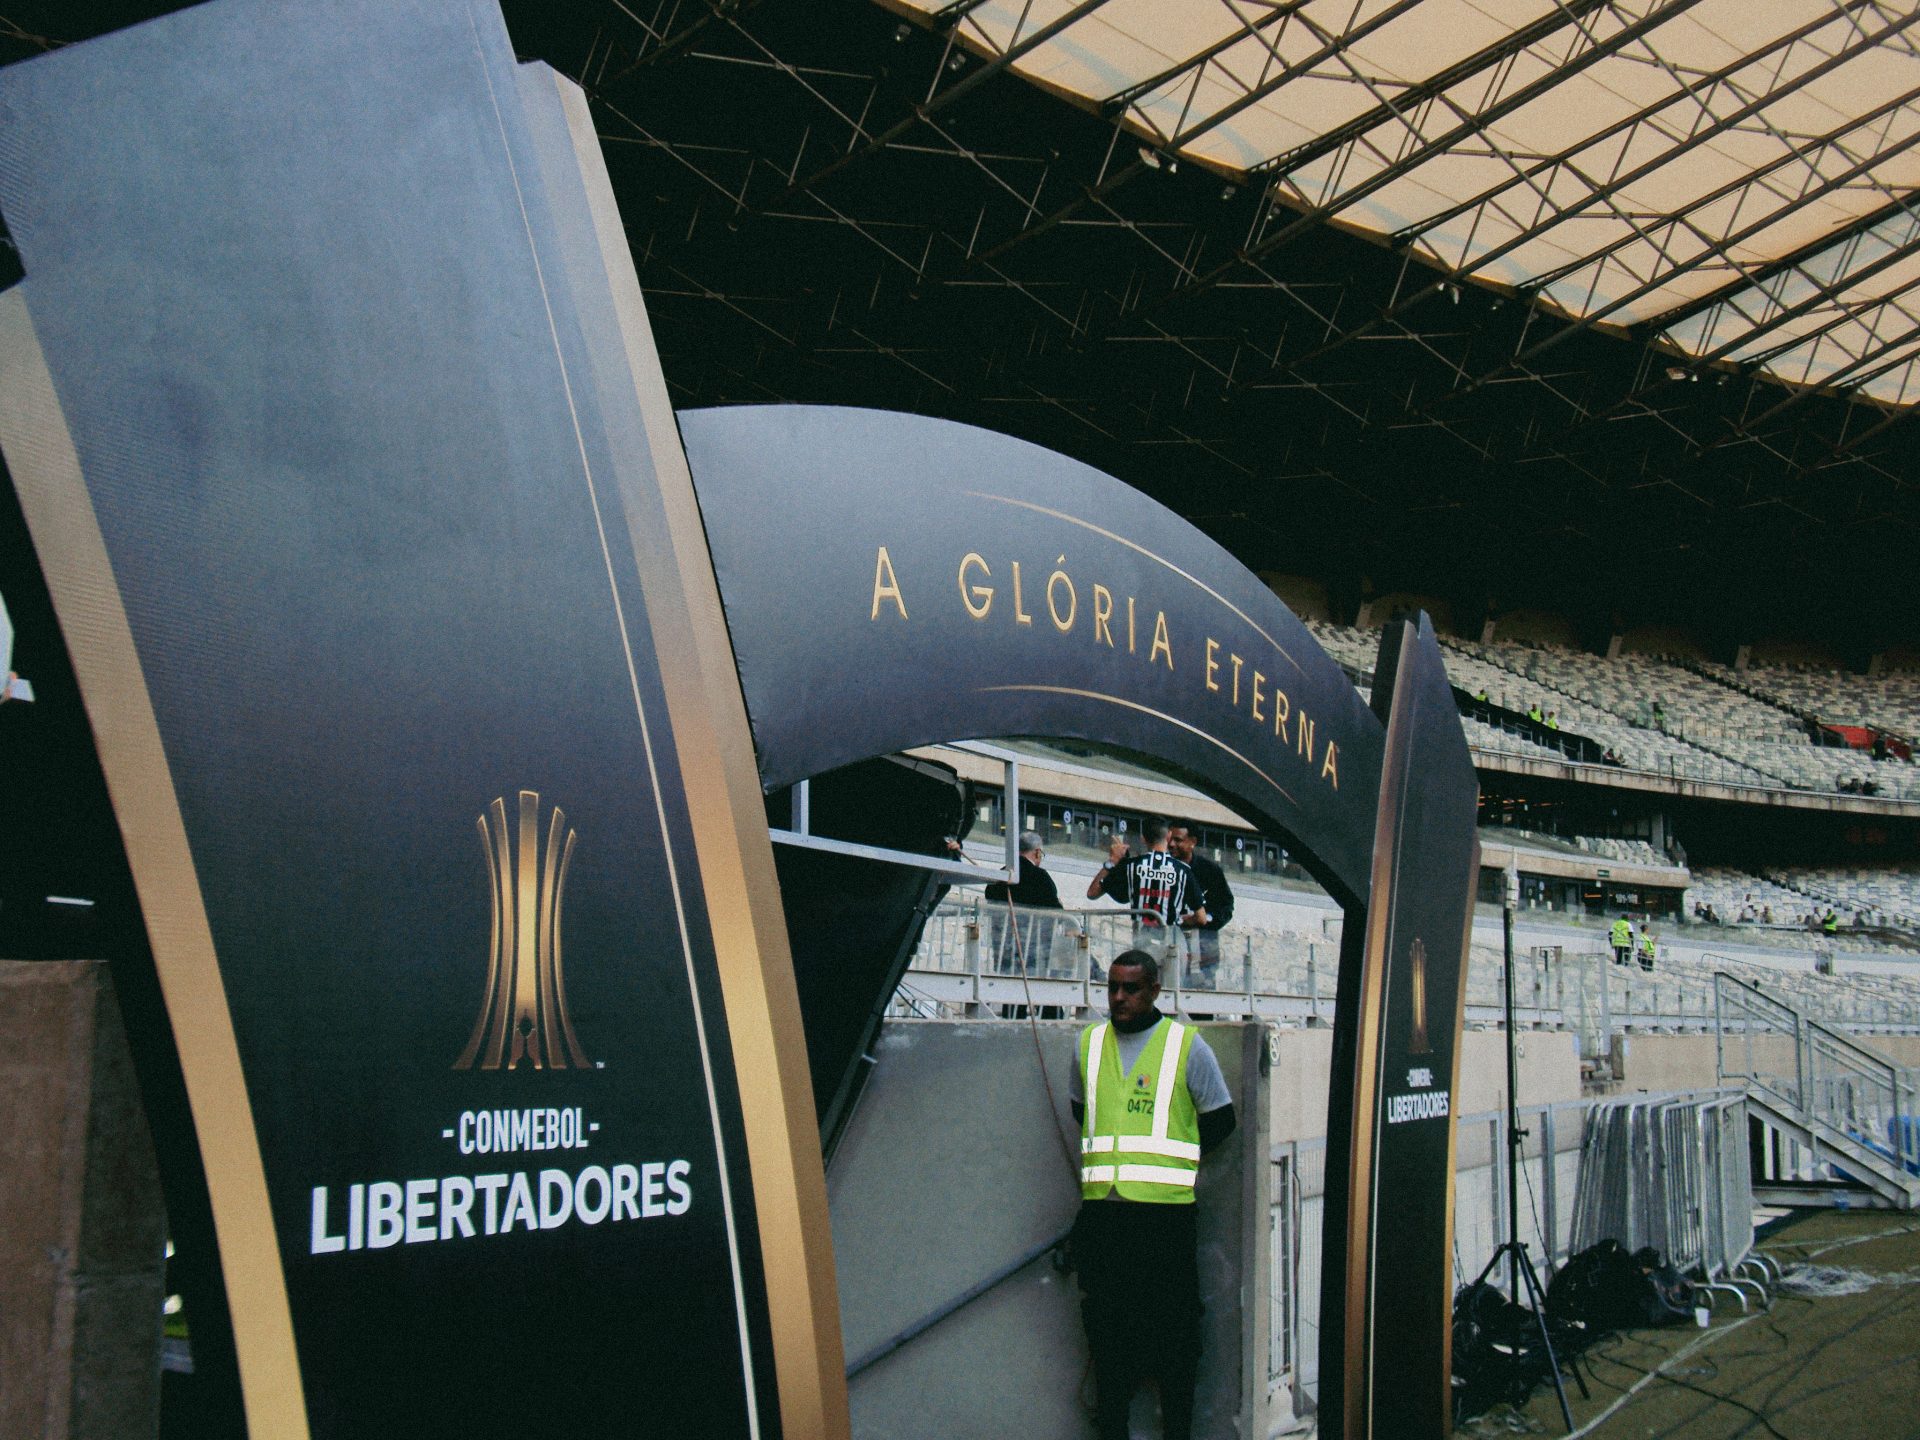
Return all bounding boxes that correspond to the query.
[1713,972,1920,1210]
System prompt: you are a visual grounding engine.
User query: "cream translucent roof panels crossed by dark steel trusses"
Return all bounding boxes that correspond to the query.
[889,0,1920,405]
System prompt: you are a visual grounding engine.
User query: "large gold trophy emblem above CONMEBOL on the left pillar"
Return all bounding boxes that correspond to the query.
[453,789,591,1069]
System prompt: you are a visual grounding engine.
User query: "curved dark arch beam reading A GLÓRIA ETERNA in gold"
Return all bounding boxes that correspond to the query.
[680,405,1380,899]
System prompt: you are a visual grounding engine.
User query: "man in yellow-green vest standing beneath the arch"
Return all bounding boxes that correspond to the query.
[1068,950,1235,1440]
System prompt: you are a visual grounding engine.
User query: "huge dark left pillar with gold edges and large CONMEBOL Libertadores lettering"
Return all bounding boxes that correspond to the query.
[0,0,845,1438]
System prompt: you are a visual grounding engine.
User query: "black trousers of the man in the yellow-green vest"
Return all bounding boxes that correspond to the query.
[1073,1200,1200,1440]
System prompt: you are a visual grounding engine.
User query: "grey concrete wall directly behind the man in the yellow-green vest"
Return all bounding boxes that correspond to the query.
[828,1021,1269,1440]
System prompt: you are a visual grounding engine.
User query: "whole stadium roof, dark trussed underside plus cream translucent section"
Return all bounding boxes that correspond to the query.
[11,0,1920,649]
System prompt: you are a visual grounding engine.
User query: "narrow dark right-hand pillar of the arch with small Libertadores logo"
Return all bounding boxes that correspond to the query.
[1319,614,1480,1440]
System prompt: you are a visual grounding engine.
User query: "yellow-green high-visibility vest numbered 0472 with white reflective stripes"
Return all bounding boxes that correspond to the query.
[1079,1020,1200,1204]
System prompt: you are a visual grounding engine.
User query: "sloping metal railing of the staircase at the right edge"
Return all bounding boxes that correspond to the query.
[1715,973,1920,1175]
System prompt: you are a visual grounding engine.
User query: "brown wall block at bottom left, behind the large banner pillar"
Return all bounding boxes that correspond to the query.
[0,960,167,1440]
